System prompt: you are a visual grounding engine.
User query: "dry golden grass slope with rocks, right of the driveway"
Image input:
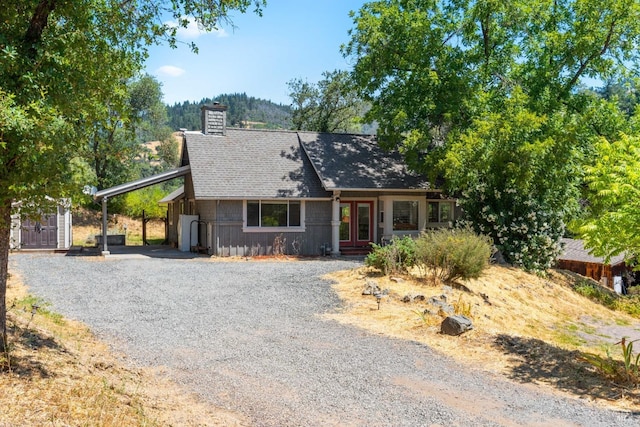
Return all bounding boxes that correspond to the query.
[328,266,640,410]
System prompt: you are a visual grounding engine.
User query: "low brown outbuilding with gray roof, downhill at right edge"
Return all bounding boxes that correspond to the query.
[557,239,628,287]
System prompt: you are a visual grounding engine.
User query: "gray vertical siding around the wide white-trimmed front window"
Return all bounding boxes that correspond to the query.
[197,200,331,256]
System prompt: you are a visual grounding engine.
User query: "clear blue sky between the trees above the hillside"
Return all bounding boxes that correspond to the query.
[146,0,365,105]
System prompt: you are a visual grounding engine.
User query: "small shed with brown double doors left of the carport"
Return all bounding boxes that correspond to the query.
[9,201,73,250]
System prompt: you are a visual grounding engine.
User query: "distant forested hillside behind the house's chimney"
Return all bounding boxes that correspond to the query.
[167,93,291,130]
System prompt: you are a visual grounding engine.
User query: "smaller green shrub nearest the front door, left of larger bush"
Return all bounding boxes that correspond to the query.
[364,236,416,274]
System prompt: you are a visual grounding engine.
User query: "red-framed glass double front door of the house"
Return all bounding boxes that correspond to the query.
[340,201,373,246]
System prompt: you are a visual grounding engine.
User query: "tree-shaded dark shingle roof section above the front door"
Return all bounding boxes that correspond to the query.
[299,132,431,190]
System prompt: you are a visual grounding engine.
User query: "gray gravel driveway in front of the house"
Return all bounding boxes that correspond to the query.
[10,254,640,426]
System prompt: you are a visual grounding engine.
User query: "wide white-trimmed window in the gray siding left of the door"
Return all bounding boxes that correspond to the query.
[247,200,302,227]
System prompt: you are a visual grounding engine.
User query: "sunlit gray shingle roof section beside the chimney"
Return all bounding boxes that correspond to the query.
[185,129,330,199]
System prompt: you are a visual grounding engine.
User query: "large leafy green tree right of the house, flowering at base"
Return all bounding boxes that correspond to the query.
[344,0,640,271]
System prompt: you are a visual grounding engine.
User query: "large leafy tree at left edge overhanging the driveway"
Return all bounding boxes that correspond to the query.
[0,0,265,351]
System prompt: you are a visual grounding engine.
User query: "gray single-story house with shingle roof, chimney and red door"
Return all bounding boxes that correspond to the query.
[96,105,459,256]
